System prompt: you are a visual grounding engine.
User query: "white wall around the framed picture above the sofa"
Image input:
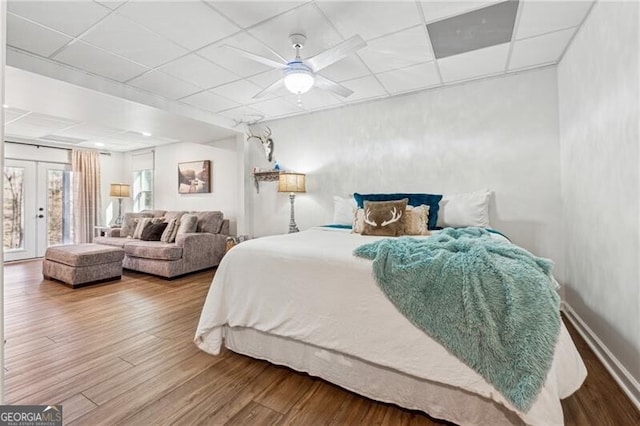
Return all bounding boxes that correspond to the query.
[154,140,244,234]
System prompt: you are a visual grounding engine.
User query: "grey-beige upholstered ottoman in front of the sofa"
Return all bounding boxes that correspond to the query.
[42,244,124,288]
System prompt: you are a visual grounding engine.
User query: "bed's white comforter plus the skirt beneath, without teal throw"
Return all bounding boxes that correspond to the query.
[195,227,586,425]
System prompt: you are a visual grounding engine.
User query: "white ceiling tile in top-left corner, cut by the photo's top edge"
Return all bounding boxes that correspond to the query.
[7,1,111,36]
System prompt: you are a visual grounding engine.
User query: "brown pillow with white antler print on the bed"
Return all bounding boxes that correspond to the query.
[362,198,409,237]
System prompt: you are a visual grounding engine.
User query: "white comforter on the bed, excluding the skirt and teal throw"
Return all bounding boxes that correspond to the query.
[195,228,586,425]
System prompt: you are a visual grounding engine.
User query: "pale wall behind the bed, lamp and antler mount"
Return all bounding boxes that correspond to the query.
[248,68,563,279]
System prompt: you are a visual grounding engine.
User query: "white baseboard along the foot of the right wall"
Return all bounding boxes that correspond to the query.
[560,301,640,411]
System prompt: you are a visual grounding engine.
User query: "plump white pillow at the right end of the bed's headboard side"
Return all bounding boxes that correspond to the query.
[438,189,491,228]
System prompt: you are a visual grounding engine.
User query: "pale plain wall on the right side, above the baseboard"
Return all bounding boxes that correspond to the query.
[558,2,640,400]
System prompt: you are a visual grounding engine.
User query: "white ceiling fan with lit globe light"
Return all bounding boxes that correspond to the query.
[225,33,367,98]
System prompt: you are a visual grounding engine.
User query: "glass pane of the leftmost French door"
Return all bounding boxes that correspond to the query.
[3,167,24,250]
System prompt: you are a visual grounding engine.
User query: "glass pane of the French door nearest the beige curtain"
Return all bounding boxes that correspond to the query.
[46,169,73,246]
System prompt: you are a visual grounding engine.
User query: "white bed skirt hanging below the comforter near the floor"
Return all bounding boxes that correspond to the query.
[223,326,523,426]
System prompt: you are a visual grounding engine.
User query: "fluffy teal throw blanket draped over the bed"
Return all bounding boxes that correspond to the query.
[354,228,560,412]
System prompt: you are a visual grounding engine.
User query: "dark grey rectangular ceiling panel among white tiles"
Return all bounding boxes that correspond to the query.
[427,0,518,59]
